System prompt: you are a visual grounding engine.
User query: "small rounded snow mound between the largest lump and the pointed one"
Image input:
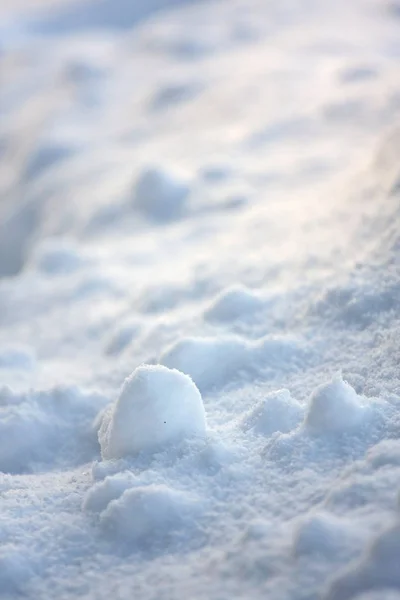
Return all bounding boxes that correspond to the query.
[241,390,303,436]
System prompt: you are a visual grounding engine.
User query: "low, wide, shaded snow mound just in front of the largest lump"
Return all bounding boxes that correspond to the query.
[100,485,202,546]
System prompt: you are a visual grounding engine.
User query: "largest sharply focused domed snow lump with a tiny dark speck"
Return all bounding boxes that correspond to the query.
[99,365,206,460]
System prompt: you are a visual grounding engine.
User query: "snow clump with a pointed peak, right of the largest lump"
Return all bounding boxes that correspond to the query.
[305,374,367,434]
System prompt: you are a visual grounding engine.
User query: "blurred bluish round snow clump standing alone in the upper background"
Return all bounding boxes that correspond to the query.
[133,167,190,221]
